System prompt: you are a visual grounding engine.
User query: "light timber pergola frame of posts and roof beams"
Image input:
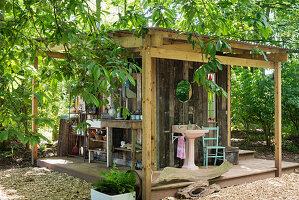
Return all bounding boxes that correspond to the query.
[32,28,289,200]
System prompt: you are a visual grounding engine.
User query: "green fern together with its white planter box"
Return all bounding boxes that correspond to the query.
[91,164,136,200]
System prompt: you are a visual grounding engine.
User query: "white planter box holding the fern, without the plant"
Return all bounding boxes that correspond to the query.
[91,189,136,200]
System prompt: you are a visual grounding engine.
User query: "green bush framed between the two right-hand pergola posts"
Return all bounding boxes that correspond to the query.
[231,67,274,145]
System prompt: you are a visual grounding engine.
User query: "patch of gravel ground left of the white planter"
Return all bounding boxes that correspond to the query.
[0,167,91,200]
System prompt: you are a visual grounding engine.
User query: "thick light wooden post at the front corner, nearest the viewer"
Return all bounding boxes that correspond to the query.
[142,35,153,200]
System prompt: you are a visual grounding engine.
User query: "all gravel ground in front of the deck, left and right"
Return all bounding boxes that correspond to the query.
[0,167,299,200]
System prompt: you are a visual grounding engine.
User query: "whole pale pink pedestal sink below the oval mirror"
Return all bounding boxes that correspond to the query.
[172,124,209,170]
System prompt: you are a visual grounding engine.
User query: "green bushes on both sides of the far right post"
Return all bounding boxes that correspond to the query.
[232,58,299,146]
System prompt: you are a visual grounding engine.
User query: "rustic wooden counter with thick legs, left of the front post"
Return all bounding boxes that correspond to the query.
[101,119,142,169]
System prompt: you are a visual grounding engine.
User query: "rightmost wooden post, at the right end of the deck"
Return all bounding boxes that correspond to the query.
[274,62,282,177]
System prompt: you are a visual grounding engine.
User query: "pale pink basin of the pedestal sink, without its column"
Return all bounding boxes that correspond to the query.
[172,124,209,139]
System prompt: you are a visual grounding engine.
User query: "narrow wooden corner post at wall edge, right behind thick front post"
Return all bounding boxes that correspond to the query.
[151,58,157,170]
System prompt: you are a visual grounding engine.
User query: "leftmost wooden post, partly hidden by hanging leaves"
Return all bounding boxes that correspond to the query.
[31,51,38,166]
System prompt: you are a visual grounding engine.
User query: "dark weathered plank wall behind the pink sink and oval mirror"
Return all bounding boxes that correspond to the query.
[157,59,227,168]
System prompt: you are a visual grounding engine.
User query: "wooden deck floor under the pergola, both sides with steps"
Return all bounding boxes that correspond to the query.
[38,157,299,199]
